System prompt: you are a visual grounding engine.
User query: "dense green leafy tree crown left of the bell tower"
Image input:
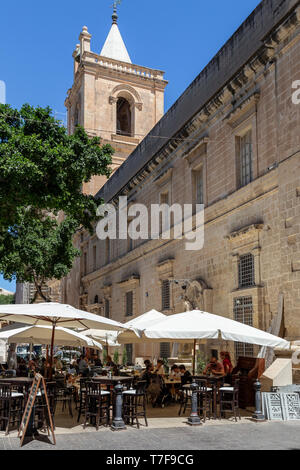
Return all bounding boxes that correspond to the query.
[0,105,114,300]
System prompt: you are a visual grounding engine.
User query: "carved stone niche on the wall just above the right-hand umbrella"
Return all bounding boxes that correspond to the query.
[183,279,213,313]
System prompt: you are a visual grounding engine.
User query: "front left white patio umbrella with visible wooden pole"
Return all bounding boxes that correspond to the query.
[0,302,123,372]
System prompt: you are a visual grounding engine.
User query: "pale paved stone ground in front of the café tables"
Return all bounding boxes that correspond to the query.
[0,422,300,450]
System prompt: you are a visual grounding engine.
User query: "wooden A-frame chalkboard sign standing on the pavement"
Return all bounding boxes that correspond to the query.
[18,374,56,447]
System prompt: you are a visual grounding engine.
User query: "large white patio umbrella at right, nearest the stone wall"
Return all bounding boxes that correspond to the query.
[143,310,290,368]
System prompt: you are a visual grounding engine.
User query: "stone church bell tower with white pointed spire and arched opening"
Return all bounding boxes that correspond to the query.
[65,2,167,195]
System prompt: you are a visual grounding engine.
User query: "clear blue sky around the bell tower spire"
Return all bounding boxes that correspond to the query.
[0,0,260,290]
